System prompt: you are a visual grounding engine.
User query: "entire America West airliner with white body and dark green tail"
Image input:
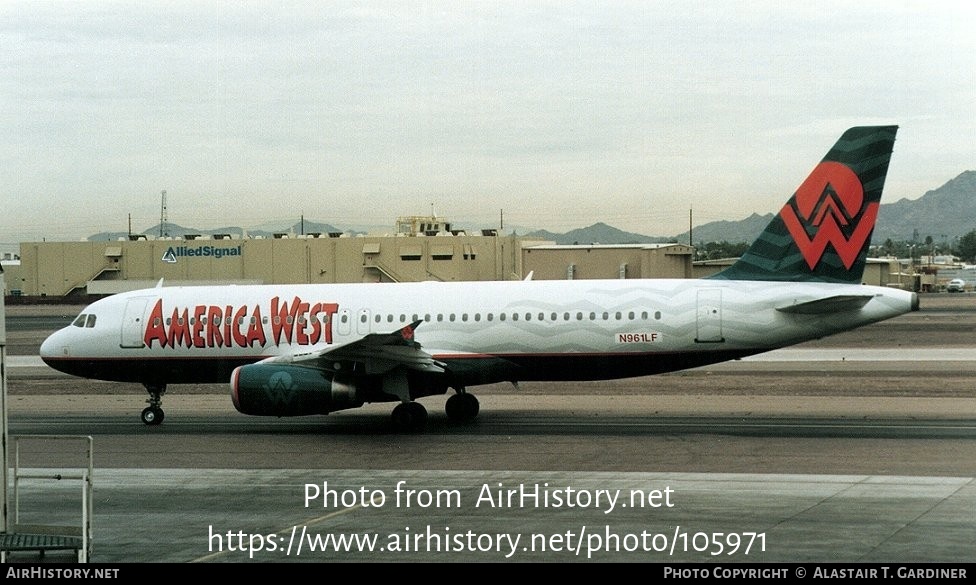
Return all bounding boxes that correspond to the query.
[40,126,918,432]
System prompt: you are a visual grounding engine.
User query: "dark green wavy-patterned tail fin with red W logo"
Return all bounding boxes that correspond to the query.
[710,126,898,283]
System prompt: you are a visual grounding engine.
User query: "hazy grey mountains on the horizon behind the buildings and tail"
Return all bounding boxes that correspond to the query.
[88,171,976,244]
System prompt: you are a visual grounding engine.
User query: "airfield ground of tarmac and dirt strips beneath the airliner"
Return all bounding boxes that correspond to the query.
[1,295,976,563]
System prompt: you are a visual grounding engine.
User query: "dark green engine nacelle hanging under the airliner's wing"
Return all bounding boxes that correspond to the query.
[230,364,365,416]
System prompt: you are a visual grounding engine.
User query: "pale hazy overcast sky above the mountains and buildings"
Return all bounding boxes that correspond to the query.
[0,0,976,243]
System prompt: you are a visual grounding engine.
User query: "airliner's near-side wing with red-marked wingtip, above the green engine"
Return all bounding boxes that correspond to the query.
[261,321,444,375]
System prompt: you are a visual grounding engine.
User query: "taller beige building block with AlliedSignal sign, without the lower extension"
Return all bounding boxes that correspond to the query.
[7,233,537,297]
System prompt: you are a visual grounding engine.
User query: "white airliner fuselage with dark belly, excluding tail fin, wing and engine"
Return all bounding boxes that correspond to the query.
[41,279,917,384]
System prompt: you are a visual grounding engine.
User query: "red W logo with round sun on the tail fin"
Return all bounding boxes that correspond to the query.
[780,161,879,270]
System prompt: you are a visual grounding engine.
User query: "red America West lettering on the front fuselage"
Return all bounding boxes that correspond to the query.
[143,297,339,348]
